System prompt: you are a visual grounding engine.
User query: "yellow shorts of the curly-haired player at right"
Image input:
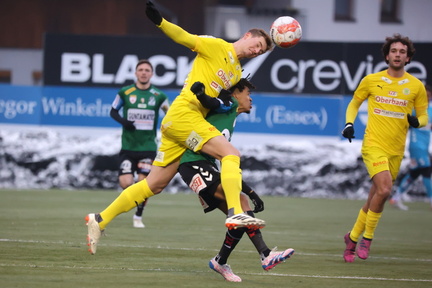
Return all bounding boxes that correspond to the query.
[362,146,403,181]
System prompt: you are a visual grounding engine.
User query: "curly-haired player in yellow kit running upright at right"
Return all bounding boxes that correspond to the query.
[342,34,428,262]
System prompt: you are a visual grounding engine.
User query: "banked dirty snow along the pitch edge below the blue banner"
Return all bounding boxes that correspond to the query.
[0,125,426,199]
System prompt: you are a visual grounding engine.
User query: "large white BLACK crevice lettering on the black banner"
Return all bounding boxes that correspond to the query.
[55,47,427,93]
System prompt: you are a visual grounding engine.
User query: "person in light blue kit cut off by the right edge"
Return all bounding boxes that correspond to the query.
[390,85,432,210]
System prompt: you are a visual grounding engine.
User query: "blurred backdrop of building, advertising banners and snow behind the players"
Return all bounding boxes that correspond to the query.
[0,0,432,197]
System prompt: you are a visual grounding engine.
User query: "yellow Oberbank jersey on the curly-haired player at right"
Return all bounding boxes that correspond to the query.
[346,70,428,155]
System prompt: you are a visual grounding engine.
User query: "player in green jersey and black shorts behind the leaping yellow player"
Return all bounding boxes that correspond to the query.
[179,78,294,282]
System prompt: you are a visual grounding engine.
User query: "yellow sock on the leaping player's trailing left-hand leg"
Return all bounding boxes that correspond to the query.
[99,179,154,230]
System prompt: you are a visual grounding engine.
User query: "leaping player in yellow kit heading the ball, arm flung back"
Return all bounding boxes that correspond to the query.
[86,1,272,254]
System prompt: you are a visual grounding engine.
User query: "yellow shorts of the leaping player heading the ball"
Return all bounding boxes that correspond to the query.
[153,106,222,167]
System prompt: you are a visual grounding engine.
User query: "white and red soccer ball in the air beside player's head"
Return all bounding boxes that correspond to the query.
[270,16,302,48]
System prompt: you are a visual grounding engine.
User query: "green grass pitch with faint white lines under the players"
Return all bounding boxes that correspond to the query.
[0,190,432,288]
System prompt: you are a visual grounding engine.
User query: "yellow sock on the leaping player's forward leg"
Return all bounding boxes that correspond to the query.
[221,155,243,214]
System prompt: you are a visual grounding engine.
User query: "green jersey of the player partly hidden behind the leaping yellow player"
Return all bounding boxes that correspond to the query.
[180,98,238,164]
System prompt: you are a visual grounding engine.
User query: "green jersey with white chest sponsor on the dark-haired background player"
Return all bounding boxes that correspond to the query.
[112,84,169,151]
